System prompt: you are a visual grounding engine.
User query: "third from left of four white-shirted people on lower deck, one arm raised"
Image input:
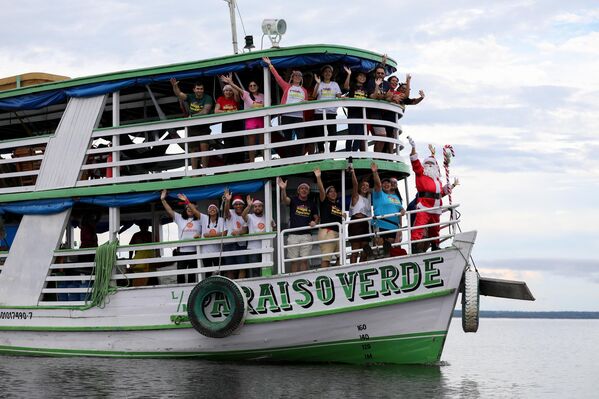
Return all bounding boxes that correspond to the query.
[223,188,247,278]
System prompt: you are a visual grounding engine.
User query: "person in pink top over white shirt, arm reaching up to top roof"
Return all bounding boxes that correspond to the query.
[262,57,308,157]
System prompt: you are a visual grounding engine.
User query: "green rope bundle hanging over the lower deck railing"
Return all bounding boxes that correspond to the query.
[86,240,119,308]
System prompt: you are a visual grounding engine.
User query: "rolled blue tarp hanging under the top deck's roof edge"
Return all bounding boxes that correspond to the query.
[0,53,394,111]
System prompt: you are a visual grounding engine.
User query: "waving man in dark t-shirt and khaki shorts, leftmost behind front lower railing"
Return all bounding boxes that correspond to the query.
[277,177,319,273]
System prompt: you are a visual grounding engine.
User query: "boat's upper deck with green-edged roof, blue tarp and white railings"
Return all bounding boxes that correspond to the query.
[0,45,408,203]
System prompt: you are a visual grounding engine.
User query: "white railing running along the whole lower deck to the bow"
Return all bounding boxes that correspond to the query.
[36,204,460,306]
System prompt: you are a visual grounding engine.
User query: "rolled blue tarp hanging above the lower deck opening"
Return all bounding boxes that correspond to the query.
[0,180,264,215]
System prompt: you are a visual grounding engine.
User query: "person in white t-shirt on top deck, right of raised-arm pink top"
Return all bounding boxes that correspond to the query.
[312,65,341,153]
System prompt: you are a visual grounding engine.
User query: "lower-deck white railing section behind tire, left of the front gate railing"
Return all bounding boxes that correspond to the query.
[40,233,276,305]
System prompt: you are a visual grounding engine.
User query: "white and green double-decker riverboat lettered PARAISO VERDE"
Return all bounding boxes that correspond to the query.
[0,24,534,364]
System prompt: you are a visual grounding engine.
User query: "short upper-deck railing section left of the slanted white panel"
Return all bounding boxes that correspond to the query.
[0,136,51,194]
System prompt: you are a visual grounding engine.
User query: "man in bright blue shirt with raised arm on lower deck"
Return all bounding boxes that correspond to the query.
[370,162,406,256]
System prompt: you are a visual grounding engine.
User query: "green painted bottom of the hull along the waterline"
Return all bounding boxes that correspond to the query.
[0,331,447,364]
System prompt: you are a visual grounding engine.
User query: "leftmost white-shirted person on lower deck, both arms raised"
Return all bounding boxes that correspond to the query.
[160,190,202,284]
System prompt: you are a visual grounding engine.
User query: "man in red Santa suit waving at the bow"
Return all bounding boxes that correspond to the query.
[408,137,458,253]
